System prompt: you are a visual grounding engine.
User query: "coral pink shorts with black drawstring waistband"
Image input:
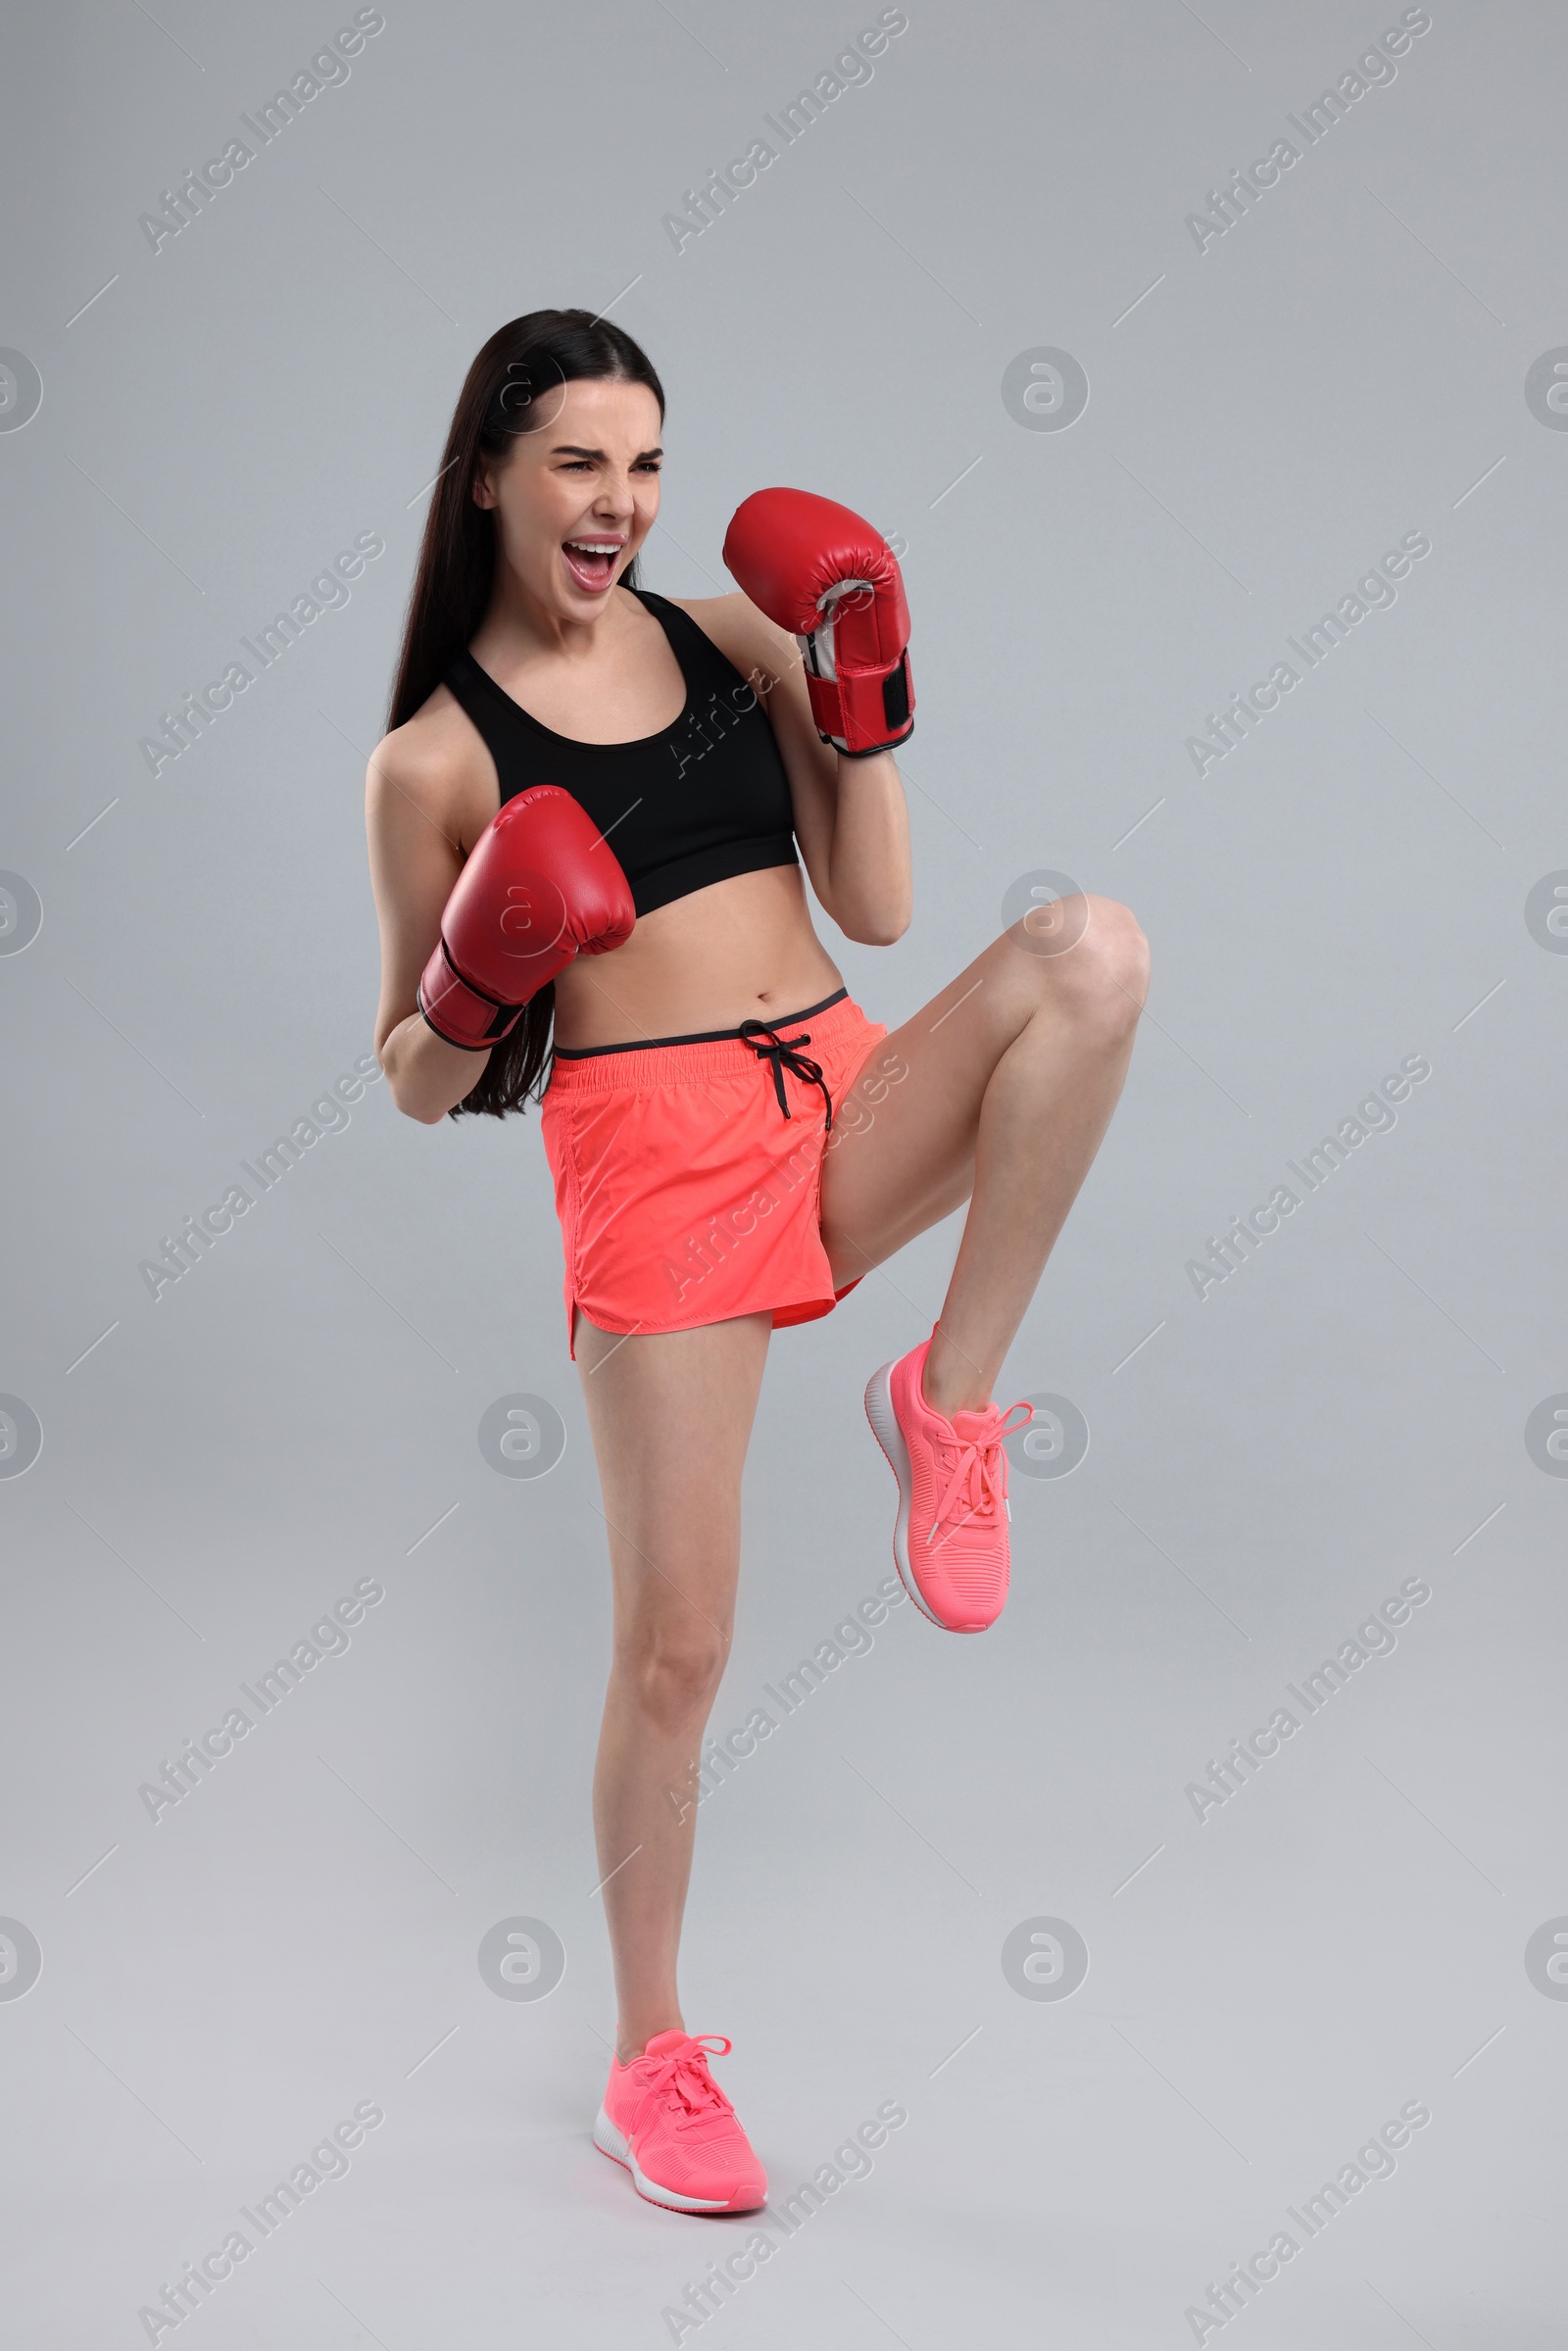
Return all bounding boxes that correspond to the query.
[541,988,886,1356]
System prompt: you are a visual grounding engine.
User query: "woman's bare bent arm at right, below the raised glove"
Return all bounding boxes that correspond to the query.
[677,590,914,948]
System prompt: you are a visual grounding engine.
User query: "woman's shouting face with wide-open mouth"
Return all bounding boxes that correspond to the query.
[475,378,661,623]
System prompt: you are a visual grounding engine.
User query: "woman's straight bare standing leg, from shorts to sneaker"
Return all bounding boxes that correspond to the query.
[576,1309,771,2064]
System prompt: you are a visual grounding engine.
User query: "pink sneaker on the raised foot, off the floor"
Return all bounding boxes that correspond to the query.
[865,1333,1034,1632]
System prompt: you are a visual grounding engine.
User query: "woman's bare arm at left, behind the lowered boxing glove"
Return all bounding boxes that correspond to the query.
[365,729,489,1126]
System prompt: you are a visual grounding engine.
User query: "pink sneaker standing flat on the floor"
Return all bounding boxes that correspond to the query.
[592,2029,768,2212]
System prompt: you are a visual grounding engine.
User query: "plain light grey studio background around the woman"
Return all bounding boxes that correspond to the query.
[0,0,1568,2351]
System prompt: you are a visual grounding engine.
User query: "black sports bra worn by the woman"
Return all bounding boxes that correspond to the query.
[442,588,800,914]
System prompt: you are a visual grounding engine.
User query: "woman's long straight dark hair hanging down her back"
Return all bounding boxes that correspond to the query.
[385,311,665,1119]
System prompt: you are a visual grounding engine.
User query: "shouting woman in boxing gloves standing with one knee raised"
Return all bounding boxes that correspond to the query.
[367,311,1148,2212]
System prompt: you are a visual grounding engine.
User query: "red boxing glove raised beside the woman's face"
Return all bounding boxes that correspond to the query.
[724,489,914,759]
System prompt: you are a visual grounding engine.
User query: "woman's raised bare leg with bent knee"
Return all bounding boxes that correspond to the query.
[823,898,1148,1415]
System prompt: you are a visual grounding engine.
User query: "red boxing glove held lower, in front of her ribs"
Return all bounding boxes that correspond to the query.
[418,783,637,1053]
